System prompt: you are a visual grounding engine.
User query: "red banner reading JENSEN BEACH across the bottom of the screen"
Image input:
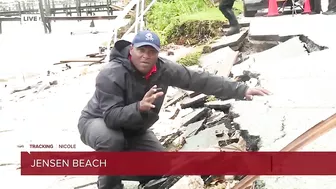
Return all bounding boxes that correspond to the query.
[21,152,336,176]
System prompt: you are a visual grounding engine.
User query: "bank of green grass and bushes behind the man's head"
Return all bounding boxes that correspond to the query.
[146,0,243,45]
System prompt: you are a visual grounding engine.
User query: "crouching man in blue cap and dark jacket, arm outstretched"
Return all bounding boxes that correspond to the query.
[78,31,268,189]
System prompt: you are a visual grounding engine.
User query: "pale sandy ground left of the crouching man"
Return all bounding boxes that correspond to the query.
[0,38,191,189]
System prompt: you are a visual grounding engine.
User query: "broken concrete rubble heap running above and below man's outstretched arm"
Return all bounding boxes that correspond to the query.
[142,34,328,189]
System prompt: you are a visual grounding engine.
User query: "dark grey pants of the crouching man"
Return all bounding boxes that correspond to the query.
[78,118,165,189]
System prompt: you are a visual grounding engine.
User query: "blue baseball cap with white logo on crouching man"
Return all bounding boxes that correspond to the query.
[132,30,160,51]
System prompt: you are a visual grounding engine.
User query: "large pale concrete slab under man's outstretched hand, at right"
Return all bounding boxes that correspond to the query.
[228,31,336,189]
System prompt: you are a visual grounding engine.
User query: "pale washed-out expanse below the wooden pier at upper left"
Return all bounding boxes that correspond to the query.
[0,13,126,79]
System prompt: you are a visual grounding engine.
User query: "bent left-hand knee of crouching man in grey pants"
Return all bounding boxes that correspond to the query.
[81,118,125,151]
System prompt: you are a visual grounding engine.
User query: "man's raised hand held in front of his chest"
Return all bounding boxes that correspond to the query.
[139,85,164,112]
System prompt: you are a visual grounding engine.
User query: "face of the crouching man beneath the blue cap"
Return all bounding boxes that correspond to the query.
[130,46,159,74]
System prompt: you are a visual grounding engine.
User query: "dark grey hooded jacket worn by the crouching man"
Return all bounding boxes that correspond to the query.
[81,41,248,132]
